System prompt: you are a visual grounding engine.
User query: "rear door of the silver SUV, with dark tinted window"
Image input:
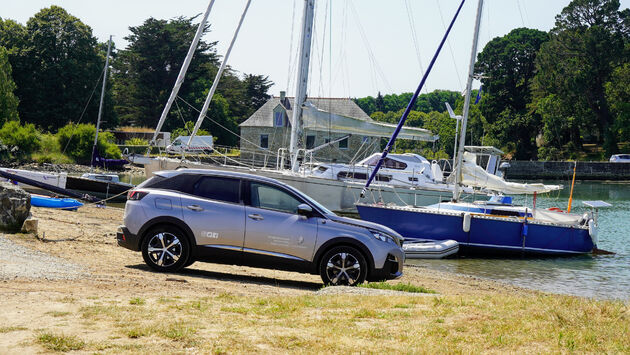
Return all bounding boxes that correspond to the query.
[181,176,245,250]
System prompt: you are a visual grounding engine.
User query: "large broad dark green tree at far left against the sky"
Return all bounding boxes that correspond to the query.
[0,6,115,130]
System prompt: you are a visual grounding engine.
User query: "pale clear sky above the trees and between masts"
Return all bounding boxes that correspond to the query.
[0,0,630,97]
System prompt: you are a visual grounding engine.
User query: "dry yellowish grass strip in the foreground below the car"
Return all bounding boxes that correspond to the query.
[33,294,630,353]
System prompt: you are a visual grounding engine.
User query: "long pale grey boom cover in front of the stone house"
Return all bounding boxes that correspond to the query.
[302,101,438,142]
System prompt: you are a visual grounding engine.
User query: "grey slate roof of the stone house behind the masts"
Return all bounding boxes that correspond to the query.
[240,96,372,127]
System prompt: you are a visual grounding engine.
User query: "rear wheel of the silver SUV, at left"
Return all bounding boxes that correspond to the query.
[142,226,190,272]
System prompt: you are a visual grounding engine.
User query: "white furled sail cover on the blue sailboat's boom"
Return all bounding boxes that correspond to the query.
[449,152,562,195]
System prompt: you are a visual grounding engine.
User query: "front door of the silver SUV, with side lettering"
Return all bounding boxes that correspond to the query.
[243,181,318,261]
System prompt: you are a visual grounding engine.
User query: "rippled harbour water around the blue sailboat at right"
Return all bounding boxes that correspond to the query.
[407,181,630,300]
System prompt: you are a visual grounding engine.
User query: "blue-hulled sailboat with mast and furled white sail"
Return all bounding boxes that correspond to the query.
[356,0,610,255]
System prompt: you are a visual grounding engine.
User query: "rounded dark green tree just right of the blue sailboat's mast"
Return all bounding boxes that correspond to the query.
[474,28,549,159]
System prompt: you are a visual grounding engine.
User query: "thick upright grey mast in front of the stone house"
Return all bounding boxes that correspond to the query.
[289,0,315,172]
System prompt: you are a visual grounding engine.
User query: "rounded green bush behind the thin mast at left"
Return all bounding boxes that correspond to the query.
[57,123,120,164]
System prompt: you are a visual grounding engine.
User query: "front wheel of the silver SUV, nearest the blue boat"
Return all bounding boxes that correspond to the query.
[319,246,368,286]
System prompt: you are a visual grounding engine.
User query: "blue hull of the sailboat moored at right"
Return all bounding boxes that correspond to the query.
[357,205,595,255]
